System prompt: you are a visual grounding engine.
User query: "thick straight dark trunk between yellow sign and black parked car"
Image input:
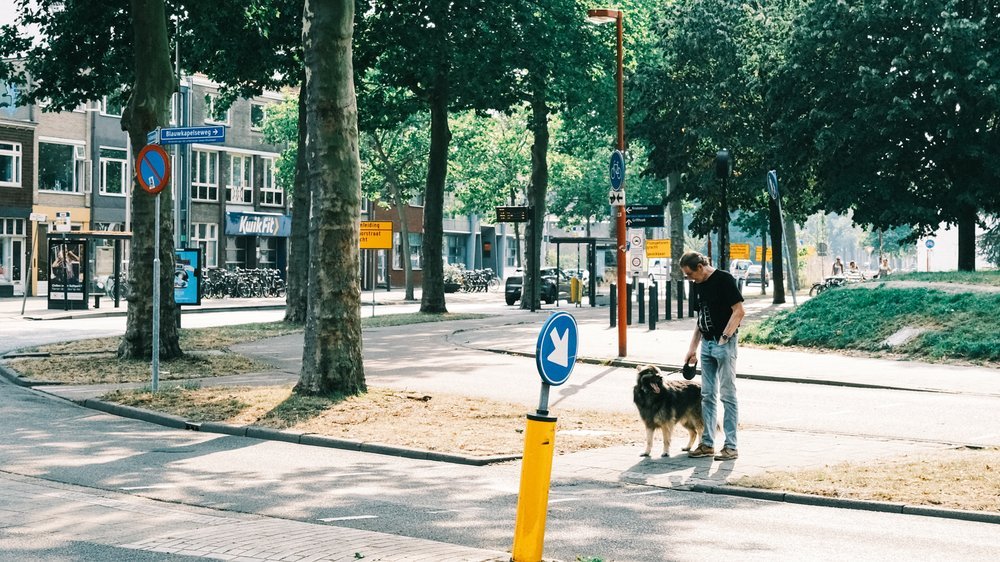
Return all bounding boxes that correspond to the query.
[420,84,451,314]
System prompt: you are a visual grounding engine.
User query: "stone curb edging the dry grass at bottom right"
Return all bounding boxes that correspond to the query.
[690,484,1000,525]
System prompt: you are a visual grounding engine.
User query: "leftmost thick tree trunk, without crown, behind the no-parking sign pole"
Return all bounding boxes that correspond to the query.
[118,0,183,360]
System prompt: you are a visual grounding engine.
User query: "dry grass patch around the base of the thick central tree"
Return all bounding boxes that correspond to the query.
[104,386,644,456]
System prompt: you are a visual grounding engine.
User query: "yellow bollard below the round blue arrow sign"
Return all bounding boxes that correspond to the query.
[512,414,556,562]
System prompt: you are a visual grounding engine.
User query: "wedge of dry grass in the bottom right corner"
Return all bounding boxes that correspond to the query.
[731,448,1000,512]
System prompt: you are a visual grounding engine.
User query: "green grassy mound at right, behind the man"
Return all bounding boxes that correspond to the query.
[744,285,1000,361]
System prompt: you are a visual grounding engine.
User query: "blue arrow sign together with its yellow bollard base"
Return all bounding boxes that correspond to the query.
[512,312,579,561]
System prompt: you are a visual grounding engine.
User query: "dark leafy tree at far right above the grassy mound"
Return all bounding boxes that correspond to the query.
[775,0,1000,271]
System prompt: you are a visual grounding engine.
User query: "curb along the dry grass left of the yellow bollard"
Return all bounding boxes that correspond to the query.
[74,398,521,466]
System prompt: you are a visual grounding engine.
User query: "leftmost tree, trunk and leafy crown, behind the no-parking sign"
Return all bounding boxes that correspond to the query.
[0,0,183,360]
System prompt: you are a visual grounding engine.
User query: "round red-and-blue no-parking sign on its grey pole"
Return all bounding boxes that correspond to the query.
[135,144,170,392]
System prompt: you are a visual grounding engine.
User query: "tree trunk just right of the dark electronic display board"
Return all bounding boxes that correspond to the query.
[521,87,558,309]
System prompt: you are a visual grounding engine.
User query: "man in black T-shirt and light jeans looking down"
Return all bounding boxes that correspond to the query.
[680,252,744,461]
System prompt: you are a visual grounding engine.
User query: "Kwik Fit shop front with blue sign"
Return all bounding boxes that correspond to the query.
[225,211,292,272]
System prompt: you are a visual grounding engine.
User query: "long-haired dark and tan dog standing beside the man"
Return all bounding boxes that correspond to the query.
[632,365,705,457]
